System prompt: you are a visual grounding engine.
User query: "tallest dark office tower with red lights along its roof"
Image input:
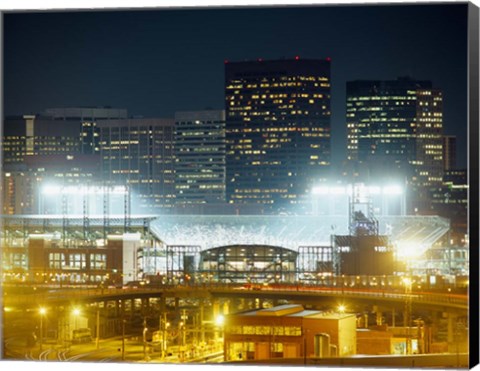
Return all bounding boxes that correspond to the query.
[225,57,331,212]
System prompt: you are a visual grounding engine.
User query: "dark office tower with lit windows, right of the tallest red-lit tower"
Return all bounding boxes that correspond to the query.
[347,78,443,214]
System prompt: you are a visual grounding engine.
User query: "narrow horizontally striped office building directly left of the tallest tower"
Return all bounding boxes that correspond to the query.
[175,110,225,205]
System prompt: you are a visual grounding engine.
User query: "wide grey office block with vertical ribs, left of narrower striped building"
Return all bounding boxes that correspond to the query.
[96,118,175,212]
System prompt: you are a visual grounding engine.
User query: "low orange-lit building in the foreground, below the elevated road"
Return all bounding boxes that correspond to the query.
[224,304,356,361]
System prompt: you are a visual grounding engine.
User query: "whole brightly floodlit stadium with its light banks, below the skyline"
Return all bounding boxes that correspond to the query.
[1,187,468,285]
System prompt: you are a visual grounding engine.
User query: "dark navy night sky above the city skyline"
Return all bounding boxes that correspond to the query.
[4,4,467,167]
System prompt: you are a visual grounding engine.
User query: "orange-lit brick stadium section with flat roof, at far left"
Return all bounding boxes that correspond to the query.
[0,215,157,285]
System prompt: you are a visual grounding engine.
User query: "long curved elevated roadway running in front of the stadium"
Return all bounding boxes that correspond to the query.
[4,284,468,313]
